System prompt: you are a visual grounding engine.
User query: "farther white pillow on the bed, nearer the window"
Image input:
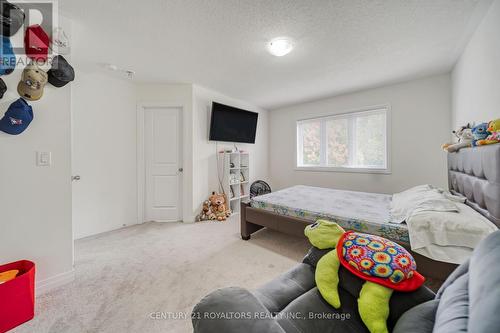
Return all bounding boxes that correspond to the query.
[391,185,463,223]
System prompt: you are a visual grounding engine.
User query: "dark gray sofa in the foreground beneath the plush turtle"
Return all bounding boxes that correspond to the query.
[193,231,500,333]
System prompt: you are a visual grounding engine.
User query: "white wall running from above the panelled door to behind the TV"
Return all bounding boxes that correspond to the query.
[137,84,268,222]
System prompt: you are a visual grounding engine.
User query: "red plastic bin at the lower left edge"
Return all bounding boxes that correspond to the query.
[0,260,35,333]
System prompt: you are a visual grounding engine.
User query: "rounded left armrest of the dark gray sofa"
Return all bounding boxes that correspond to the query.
[192,287,285,333]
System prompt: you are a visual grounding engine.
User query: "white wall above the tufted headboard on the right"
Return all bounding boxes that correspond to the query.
[452,0,500,128]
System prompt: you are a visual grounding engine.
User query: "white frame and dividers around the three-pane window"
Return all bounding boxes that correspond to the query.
[294,104,392,174]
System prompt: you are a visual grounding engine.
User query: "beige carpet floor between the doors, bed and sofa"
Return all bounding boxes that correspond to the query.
[13,219,309,333]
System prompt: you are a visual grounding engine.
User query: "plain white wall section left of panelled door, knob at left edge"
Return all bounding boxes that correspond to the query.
[72,70,137,239]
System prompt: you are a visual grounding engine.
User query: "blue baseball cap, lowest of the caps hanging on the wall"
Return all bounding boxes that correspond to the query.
[0,98,33,135]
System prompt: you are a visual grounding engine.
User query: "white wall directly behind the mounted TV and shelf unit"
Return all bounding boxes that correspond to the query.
[192,86,269,214]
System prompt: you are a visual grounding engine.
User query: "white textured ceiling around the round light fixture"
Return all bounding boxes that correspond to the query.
[59,0,491,109]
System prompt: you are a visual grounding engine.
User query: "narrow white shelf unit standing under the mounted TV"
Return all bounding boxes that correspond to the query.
[218,152,250,214]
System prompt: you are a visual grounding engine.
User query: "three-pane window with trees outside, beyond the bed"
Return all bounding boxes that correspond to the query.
[297,107,389,172]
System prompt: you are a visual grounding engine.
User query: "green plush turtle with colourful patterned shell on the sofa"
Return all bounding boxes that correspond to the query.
[304,220,425,333]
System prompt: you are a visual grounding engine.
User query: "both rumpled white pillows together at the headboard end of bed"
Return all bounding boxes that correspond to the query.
[391,185,497,264]
